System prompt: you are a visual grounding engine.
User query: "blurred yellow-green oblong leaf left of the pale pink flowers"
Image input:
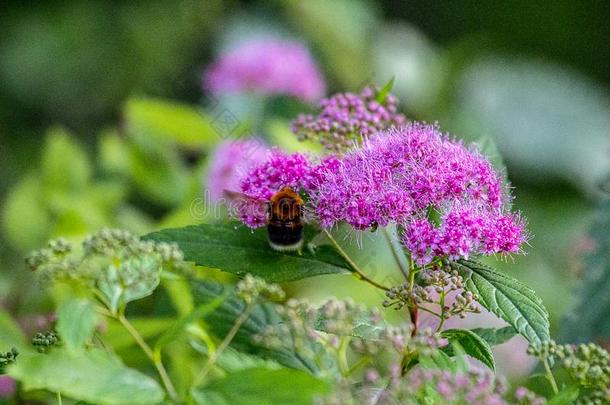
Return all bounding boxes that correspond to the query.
[125,99,220,148]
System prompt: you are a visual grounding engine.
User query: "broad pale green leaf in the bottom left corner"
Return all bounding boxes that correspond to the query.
[8,349,164,404]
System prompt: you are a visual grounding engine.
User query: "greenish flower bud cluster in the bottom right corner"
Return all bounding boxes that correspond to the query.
[527,340,610,404]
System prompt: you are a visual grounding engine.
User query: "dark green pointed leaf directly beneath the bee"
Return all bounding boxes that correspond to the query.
[144,223,349,282]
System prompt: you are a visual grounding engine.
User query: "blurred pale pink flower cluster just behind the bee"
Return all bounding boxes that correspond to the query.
[206,138,270,201]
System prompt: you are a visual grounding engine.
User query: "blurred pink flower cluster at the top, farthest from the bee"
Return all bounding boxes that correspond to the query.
[203,39,326,102]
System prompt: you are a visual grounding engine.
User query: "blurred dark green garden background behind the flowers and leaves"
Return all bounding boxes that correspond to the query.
[0,0,610,378]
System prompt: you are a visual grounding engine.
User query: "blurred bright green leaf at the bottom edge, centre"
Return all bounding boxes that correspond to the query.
[193,368,330,405]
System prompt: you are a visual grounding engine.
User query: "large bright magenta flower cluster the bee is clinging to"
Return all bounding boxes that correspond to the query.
[235,123,527,266]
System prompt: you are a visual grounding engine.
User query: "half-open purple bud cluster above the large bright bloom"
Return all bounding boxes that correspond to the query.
[292,87,406,153]
